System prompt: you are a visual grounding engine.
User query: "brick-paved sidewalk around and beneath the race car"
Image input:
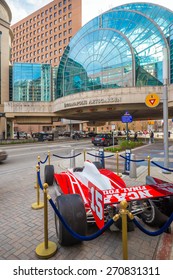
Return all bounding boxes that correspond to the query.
[0,143,173,260]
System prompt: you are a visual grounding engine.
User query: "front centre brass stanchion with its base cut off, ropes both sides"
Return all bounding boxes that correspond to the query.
[113,200,133,260]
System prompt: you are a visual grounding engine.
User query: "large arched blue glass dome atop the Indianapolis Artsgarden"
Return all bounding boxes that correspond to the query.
[56,3,173,98]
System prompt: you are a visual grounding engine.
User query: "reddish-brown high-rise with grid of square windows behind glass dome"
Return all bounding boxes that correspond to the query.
[11,0,82,66]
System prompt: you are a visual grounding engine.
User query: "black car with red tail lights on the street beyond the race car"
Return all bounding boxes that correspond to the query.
[92,133,118,146]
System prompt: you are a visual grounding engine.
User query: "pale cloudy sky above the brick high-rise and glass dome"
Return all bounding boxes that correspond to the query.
[5,0,173,24]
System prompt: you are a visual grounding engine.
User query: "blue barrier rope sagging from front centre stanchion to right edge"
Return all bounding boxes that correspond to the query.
[133,213,173,236]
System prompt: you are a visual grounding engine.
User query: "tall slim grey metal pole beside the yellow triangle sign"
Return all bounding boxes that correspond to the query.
[163,48,169,173]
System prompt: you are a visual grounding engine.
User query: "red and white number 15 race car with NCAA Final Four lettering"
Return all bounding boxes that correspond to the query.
[44,161,173,246]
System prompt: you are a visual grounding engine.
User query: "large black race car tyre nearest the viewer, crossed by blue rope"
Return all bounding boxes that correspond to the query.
[55,194,87,246]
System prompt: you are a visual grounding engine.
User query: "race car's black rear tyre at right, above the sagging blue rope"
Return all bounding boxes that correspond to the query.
[140,199,168,227]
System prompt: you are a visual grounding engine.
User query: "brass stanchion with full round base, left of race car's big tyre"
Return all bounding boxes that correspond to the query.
[35,183,58,259]
